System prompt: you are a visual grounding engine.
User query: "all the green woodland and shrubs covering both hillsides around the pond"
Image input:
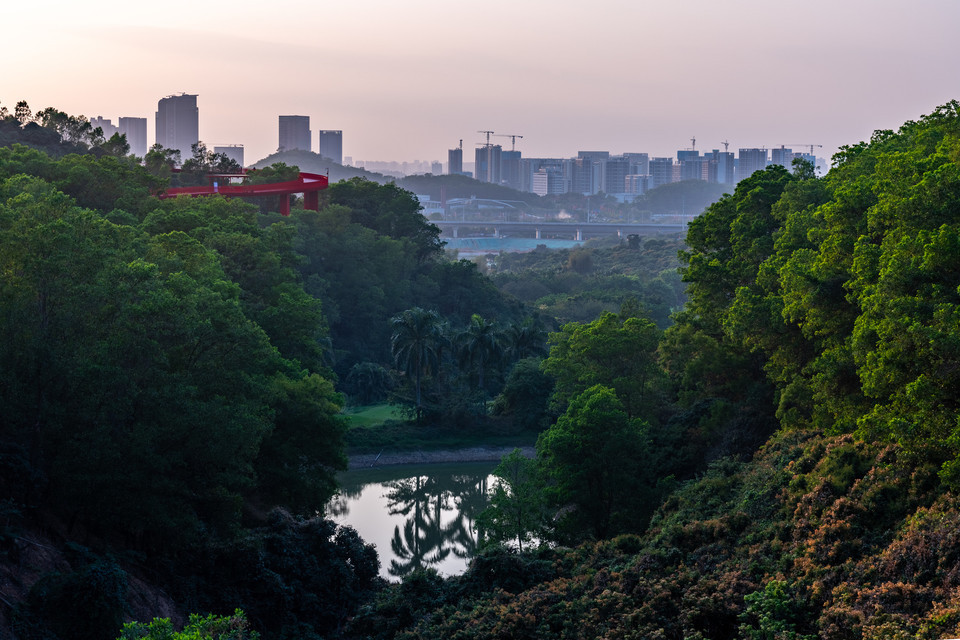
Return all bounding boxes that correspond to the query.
[0,96,960,640]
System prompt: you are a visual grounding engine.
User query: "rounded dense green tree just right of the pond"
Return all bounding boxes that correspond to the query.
[537,385,649,539]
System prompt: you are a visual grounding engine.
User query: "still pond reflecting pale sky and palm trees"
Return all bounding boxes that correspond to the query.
[327,462,497,581]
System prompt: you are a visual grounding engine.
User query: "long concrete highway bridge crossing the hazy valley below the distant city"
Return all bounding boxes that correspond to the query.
[431,220,687,242]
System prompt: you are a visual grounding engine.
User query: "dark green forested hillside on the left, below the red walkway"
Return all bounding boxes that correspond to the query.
[0,103,542,638]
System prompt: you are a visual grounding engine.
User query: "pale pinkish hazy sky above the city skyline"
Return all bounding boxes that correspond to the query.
[0,0,960,163]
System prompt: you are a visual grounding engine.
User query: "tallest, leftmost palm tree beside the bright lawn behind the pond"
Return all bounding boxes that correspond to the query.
[390,307,443,420]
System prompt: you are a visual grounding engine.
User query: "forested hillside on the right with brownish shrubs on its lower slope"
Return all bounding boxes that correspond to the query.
[353,102,960,640]
